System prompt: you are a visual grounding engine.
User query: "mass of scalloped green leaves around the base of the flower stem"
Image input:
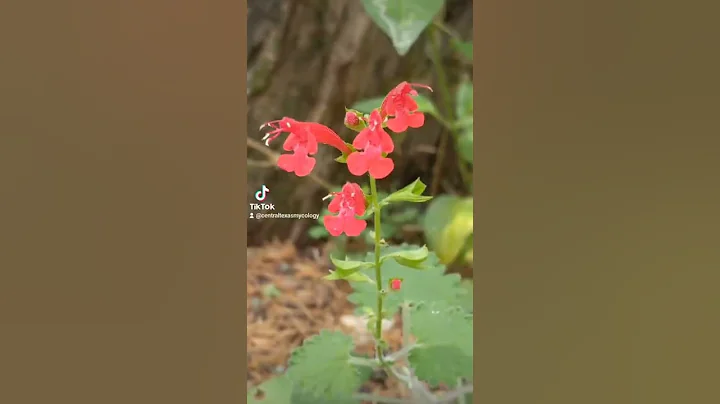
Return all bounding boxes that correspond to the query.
[248,244,473,404]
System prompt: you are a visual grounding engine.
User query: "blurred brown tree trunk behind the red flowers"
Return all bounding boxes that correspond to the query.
[247,0,472,243]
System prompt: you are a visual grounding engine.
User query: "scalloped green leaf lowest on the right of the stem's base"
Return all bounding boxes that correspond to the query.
[408,301,473,386]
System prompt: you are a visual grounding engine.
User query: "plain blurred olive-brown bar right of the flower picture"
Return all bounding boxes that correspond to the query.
[474,0,720,404]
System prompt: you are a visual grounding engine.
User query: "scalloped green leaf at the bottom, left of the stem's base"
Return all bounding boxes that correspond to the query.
[287,330,366,403]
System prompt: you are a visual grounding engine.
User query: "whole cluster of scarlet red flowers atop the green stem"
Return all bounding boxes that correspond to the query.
[260,81,432,237]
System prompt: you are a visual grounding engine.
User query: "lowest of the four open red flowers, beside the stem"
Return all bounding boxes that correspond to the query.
[323,182,367,237]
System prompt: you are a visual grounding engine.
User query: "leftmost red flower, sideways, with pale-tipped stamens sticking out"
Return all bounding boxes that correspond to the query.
[260,117,350,177]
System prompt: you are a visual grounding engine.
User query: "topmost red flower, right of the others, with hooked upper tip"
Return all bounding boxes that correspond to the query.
[380,81,432,133]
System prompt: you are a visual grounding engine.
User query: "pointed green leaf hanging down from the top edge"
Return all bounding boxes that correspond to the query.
[363,0,444,56]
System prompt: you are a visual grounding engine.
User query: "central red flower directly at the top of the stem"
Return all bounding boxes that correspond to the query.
[347,110,395,179]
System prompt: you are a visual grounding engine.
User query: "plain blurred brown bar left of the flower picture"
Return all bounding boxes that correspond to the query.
[0,0,247,404]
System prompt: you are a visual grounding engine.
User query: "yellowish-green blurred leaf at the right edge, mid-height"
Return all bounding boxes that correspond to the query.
[437,197,473,263]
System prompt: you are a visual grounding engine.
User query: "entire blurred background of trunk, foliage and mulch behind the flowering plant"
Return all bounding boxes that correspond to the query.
[247,0,473,395]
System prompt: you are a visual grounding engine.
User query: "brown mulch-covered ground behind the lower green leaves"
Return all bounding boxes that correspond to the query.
[247,243,402,397]
